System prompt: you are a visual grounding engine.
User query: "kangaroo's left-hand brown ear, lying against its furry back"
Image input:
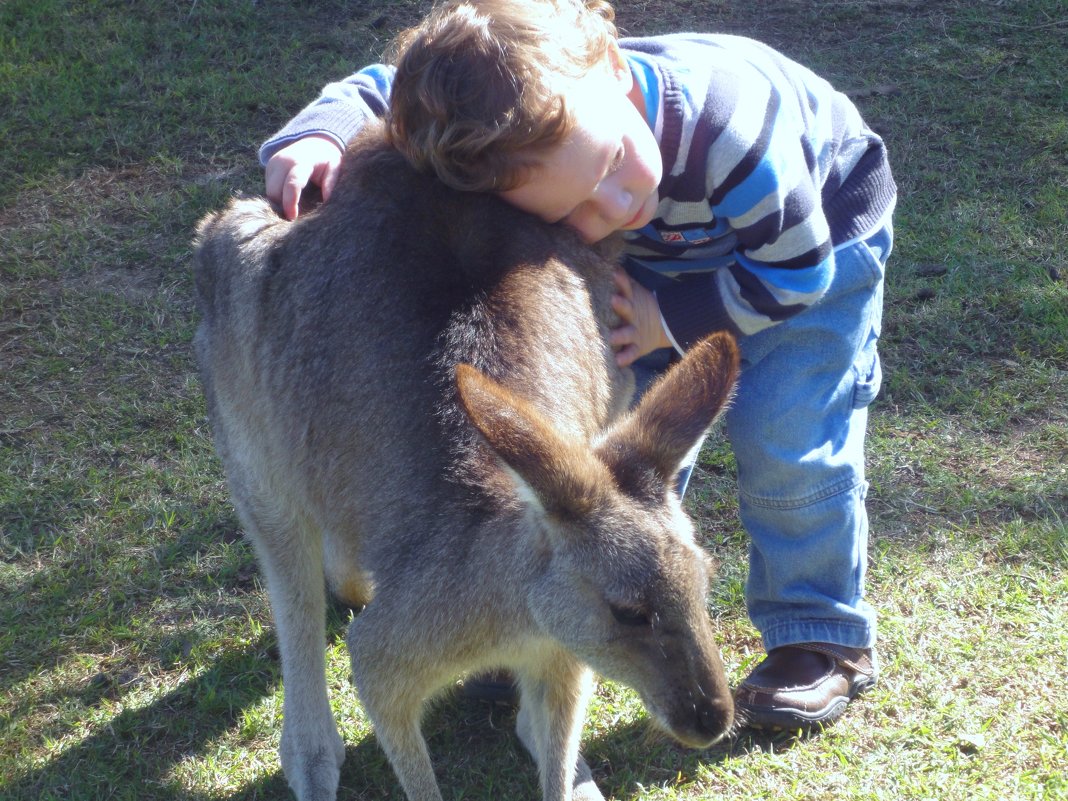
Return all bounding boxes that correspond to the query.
[456,364,612,519]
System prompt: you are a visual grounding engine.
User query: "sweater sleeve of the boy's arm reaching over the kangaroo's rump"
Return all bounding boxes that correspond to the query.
[260,64,396,166]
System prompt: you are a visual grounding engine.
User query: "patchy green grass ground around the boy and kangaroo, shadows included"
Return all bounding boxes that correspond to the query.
[0,0,1068,801]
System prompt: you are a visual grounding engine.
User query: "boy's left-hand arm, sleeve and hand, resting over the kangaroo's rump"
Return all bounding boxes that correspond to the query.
[260,64,395,220]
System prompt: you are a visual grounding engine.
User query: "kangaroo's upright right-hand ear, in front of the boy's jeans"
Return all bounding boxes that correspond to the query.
[597,332,739,489]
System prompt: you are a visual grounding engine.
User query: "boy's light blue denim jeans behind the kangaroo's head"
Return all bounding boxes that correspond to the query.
[635,221,893,650]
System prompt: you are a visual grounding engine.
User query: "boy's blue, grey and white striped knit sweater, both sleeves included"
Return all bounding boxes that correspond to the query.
[260,34,896,350]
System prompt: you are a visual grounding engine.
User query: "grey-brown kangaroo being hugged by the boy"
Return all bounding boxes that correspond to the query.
[195,127,738,801]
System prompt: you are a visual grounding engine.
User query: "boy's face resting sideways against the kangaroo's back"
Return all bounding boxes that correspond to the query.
[501,51,663,242]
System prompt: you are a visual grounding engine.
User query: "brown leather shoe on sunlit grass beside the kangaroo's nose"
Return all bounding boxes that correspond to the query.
[735,643,879,729]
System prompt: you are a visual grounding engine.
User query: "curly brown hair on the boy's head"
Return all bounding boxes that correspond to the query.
[388,0,617,191]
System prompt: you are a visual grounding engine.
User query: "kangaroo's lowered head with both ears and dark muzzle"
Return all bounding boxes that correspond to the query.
[457,334,738,747]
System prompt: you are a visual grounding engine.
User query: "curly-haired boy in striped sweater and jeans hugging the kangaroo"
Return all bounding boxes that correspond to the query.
[261,0,896,729]
